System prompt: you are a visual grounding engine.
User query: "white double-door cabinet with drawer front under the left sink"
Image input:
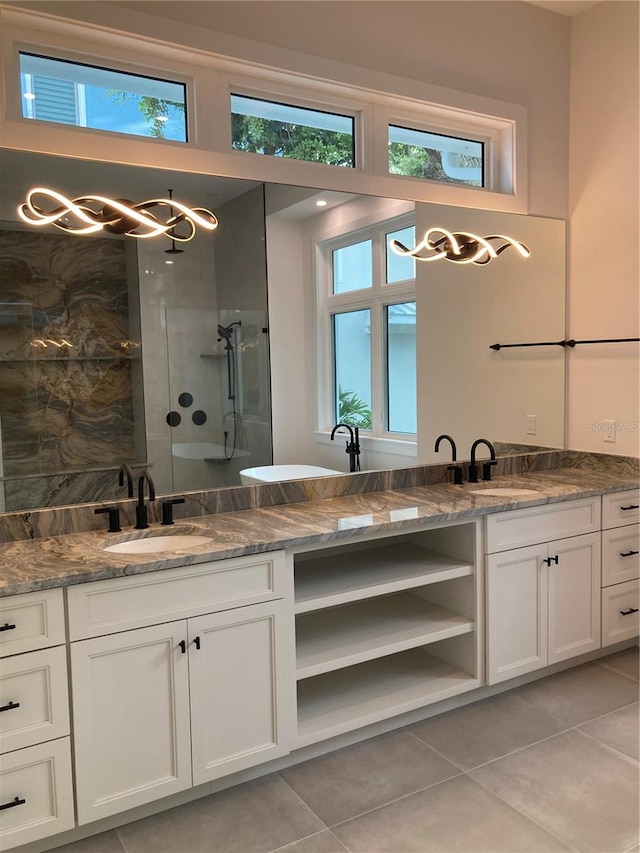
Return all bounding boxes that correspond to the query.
[68,552,294,824]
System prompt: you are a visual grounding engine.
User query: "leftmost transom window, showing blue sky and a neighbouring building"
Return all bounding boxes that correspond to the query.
[20,53,187,142]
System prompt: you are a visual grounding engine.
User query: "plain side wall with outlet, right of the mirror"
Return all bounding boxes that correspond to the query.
[567,2,640,455]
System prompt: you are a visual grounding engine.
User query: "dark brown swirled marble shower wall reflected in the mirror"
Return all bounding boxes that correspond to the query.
[0,229,141,510]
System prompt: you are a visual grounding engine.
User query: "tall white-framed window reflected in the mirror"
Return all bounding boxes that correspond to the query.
[319,215,417,438]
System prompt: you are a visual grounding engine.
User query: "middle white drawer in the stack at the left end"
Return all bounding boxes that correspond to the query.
[0,646,69,752]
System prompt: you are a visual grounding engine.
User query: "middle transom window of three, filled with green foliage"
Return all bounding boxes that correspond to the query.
[231,95,356,168]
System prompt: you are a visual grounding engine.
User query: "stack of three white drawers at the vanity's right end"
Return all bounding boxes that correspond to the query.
[602,489,640,646]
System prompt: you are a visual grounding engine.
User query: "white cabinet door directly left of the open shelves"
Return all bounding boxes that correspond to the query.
[189,601,295,785]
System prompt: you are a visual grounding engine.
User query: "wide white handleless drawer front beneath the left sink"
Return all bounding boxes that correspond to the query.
[67,551,286,640]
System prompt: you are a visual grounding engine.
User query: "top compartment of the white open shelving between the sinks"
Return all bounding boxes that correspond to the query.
[295,542,473,613]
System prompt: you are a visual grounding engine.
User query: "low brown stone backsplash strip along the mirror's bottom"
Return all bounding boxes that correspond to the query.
[0,450,640,542]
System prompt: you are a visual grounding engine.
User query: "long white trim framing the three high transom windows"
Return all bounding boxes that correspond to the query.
[0,6,527,213]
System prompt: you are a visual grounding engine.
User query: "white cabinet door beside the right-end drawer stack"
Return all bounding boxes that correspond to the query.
[548,533,600,664]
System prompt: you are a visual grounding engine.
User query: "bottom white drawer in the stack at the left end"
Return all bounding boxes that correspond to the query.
[0,738,74,850]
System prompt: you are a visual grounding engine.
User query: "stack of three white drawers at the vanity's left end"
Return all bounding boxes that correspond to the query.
[0,589,74,850]
